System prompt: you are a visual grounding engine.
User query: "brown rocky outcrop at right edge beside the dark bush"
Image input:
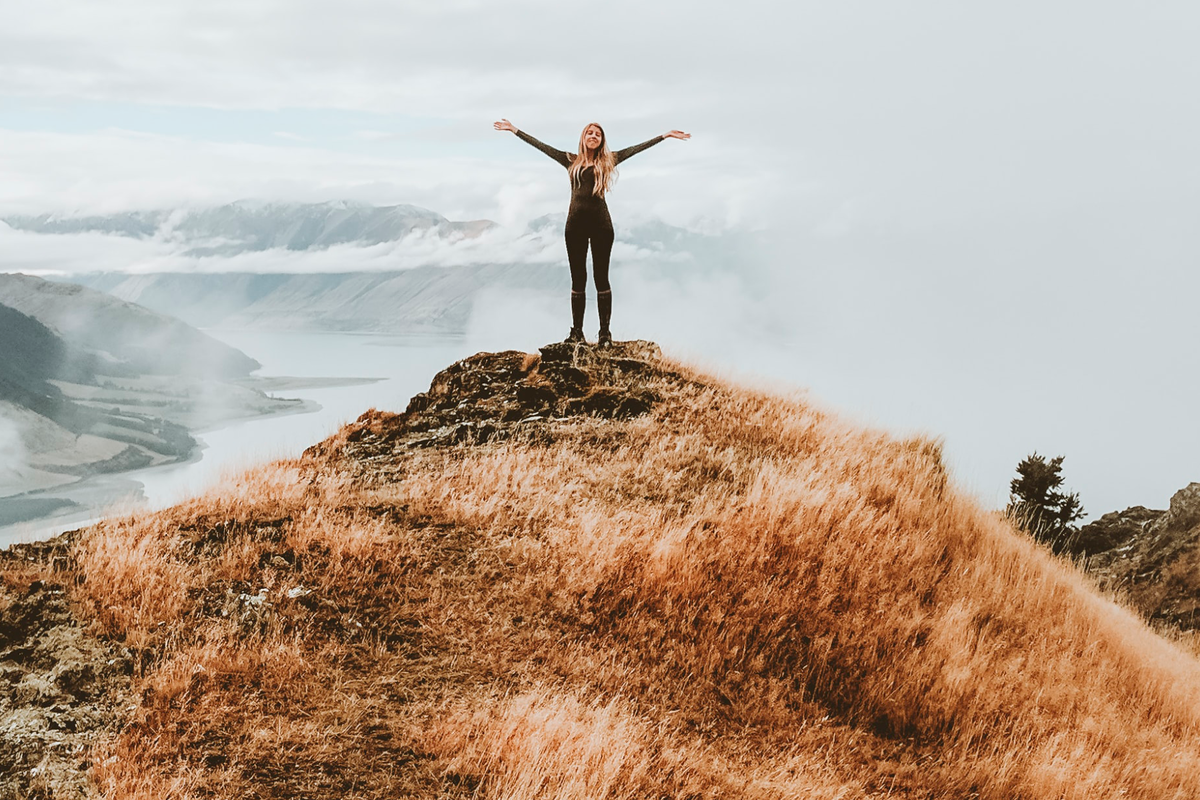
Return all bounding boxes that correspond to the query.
[1070,483,1200,631]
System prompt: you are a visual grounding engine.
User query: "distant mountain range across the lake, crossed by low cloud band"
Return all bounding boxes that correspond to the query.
[11,201,757,335]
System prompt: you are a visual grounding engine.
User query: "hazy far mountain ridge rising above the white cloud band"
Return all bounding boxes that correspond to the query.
[4,200,496,255]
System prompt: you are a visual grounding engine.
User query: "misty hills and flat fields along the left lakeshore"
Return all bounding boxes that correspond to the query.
[0,273,306,515]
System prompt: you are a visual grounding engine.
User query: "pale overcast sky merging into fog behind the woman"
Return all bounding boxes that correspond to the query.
[0,0,1200,512]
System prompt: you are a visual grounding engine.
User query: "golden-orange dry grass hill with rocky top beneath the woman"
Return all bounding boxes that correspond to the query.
[2,344,1200,800]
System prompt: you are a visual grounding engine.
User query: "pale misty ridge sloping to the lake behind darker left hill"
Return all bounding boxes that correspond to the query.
[0,273,260,378]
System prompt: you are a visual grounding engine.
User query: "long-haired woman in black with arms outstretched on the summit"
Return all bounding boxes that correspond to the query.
[493,120,691,345]
